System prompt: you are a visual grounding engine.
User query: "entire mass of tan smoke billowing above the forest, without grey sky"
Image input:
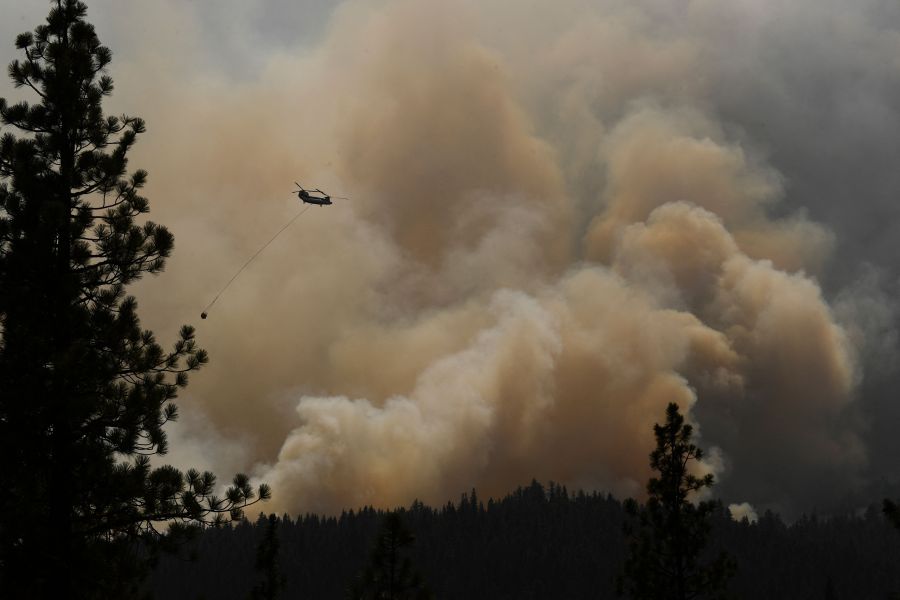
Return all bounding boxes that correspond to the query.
[88,0,865,512]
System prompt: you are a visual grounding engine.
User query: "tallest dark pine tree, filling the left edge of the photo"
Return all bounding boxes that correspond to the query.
[0,0,269,598]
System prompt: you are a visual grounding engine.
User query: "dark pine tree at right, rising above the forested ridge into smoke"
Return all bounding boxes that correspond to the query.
[618,403,736,600]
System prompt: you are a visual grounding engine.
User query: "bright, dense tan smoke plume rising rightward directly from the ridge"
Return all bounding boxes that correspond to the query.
[265,203,862,510]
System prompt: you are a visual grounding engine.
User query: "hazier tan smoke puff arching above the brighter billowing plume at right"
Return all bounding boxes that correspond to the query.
[586,105,832,272]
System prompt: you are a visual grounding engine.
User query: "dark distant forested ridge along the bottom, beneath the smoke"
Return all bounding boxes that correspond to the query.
[151,482,900,600]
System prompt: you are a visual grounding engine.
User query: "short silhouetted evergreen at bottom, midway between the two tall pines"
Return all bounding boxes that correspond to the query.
[348,511,433,600]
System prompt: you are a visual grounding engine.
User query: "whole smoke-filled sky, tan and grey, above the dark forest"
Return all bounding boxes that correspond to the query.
[0,0,900,515]
